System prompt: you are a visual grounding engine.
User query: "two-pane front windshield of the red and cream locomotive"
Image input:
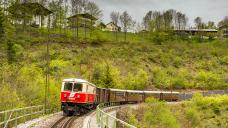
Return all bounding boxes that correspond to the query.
[64,83,82,92]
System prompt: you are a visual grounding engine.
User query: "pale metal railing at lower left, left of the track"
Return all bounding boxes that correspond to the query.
[0,105,45,128]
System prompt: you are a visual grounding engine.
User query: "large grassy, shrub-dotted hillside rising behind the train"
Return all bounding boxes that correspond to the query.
[0,27,228,109]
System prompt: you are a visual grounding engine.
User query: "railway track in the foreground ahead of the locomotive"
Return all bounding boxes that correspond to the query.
[51,116,77,128]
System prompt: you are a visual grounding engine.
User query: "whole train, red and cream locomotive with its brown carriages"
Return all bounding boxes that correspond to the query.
[60,78,179,115]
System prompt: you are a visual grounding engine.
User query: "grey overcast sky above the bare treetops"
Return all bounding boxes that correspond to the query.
[90,0,228,25]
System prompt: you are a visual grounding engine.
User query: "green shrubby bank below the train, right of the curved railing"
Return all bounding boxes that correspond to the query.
[117,94,228,128]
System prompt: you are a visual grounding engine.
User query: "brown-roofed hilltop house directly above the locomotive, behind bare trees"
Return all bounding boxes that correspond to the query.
[67,13,97,29]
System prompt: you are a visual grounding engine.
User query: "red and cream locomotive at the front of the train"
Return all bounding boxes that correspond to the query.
[61,78,96,115]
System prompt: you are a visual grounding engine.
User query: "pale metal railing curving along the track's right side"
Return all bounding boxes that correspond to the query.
[96,102,136,128]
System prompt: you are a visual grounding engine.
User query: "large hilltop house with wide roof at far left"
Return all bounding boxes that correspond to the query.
[9,2,52,27]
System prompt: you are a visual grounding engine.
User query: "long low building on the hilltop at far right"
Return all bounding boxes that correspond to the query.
[174,29,218,38]
